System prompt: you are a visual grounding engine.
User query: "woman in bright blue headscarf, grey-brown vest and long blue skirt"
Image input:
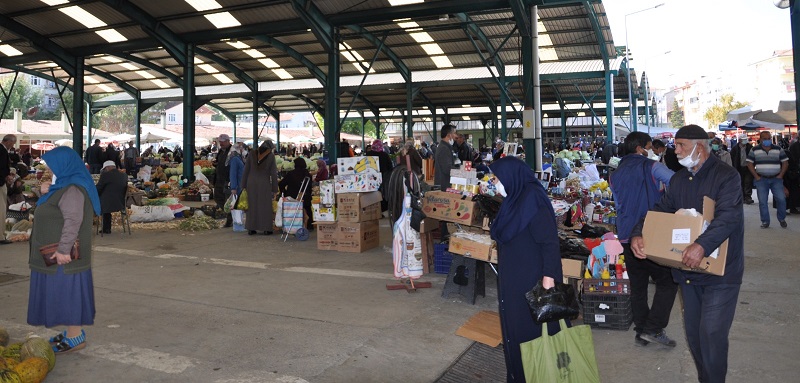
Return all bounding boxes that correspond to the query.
[28,146,100,354]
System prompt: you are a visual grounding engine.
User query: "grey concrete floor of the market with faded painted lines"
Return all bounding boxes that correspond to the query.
[0,198,800,383]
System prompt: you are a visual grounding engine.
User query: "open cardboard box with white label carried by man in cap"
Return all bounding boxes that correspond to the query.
[642,197,728,275]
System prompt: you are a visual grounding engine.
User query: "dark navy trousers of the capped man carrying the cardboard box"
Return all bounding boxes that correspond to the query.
[681,284,741,383]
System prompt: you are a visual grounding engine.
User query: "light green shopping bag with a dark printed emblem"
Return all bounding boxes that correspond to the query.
[519,319,600,383]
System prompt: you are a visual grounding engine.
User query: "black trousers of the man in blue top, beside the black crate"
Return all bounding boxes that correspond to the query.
[622,243,678,334]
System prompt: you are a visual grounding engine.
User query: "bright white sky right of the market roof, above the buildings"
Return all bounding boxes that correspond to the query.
[603,0,792,88]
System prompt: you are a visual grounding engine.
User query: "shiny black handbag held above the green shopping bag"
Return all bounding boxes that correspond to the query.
[525,280,580,323]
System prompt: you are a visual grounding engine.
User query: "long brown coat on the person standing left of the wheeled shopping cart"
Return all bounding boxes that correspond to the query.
[242,149,278,231]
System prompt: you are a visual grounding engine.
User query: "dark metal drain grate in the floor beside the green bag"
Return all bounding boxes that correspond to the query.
[436,342,506,383]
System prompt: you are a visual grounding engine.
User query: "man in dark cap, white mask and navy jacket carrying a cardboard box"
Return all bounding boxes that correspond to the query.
[631,125,744,382]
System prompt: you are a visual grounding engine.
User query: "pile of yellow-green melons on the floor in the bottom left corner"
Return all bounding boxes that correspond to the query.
[0,327,56,383]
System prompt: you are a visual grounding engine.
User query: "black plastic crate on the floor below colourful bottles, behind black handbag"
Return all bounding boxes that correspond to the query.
[582,294,633,331]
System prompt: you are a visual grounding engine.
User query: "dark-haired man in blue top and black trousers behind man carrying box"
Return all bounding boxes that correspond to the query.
[610,132,678,347]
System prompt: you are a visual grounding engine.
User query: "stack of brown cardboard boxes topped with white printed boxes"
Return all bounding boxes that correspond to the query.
[312,157,383,253]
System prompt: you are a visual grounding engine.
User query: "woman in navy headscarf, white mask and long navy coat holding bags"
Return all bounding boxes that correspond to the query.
[490,157,562,382]
